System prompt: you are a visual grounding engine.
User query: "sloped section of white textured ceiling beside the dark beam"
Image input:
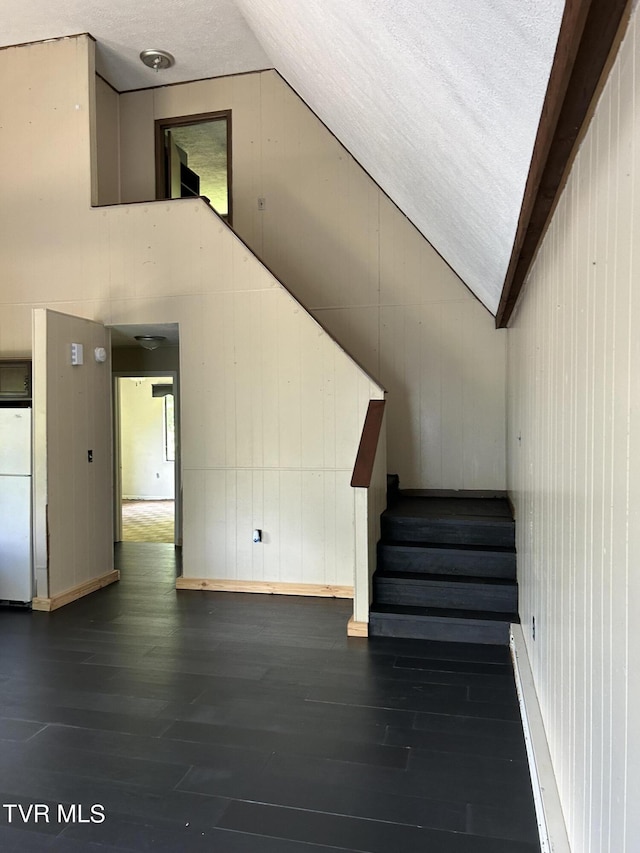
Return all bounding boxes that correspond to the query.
[232,0,564,313]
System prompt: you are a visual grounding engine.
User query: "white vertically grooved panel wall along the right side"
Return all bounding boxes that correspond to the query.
[508,12,640,853]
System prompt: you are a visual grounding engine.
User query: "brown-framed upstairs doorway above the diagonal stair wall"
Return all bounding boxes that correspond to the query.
[156,110,232,224]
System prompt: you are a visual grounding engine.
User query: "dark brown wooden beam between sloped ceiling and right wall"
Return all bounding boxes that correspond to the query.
[496,0,630,328]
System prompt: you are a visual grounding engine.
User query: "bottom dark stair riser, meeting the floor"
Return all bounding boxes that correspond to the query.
[369,613,510,646]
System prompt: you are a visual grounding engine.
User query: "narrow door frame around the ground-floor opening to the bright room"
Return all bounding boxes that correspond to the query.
[112,370,182,547]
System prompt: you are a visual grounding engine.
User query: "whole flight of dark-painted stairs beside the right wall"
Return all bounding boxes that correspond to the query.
[369,481,520,644]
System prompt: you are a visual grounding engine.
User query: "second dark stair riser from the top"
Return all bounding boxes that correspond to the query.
[378,543,516,580]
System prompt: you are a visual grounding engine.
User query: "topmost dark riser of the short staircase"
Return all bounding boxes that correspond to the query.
[381,516,515,548]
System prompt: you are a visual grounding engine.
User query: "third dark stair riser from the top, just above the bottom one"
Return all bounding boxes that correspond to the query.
[374,577,518,613]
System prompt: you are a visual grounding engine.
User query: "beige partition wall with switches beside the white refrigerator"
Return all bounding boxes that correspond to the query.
[33,308,113,599]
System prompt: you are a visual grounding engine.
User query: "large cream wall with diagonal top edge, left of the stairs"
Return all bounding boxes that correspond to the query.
[0,36,383,585]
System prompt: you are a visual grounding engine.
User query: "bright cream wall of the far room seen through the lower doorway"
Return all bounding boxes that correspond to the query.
[118,376,175,500]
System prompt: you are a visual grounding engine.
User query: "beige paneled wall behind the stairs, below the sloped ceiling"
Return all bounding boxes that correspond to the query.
[120,71,506,489]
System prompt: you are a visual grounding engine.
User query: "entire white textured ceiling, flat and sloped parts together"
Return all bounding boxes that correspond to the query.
[0,0,564,313]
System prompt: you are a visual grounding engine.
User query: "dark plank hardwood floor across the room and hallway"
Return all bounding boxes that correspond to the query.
[0,543,539,853]
